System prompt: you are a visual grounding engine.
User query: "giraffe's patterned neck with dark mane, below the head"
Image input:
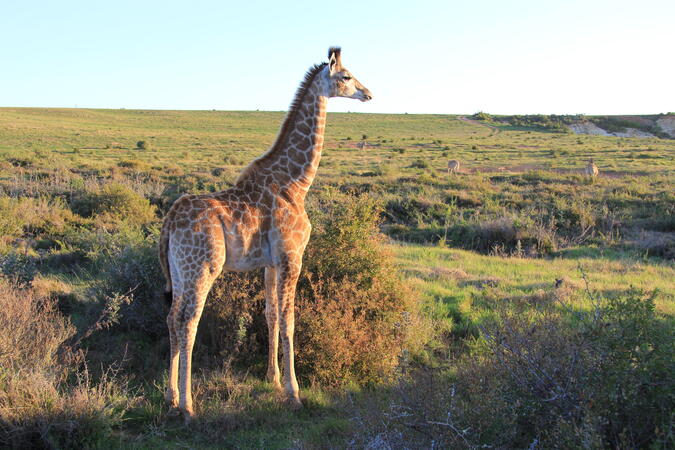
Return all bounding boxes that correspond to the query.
[240,67,328,199]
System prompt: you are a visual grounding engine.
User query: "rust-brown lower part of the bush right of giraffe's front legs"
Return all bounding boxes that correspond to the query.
[297,278,423,386]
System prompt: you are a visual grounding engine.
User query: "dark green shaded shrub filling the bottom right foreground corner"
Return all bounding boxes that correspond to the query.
[359,287,675,448]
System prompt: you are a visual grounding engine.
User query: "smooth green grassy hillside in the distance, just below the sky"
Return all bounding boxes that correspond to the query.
[0,108,675,178]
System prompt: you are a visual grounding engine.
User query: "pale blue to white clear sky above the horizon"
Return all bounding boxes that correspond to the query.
[0,0,675,114]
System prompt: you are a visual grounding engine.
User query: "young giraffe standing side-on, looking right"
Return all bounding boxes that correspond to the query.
[159,47,372,422]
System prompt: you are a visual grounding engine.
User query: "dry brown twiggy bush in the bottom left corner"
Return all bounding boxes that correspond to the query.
[0,279,132,448]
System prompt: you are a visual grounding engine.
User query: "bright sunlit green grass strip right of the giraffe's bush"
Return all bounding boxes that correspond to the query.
[393,244,675,321]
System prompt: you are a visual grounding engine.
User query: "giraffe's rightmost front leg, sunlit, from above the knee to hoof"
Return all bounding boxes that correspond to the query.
[277,260,302,407]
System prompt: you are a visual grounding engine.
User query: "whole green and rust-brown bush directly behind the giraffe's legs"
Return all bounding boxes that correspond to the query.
[195,192,430,385]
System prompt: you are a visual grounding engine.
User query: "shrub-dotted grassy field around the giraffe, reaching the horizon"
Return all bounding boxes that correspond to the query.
[0,108,675,448]
